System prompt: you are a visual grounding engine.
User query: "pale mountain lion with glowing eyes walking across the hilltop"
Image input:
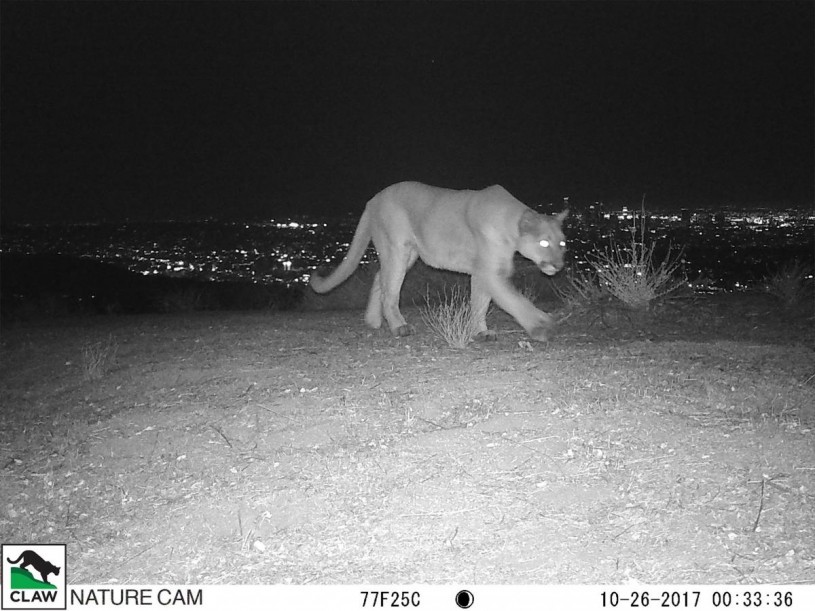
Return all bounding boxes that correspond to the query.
[310,182,568,341]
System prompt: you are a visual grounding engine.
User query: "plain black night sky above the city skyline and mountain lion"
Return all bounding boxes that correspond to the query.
[0,0,815,222]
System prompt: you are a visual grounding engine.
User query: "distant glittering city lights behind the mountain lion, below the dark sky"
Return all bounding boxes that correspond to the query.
[0,202,815,291]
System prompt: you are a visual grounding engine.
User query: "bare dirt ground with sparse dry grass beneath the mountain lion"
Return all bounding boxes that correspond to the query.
[0,295,815,584]
